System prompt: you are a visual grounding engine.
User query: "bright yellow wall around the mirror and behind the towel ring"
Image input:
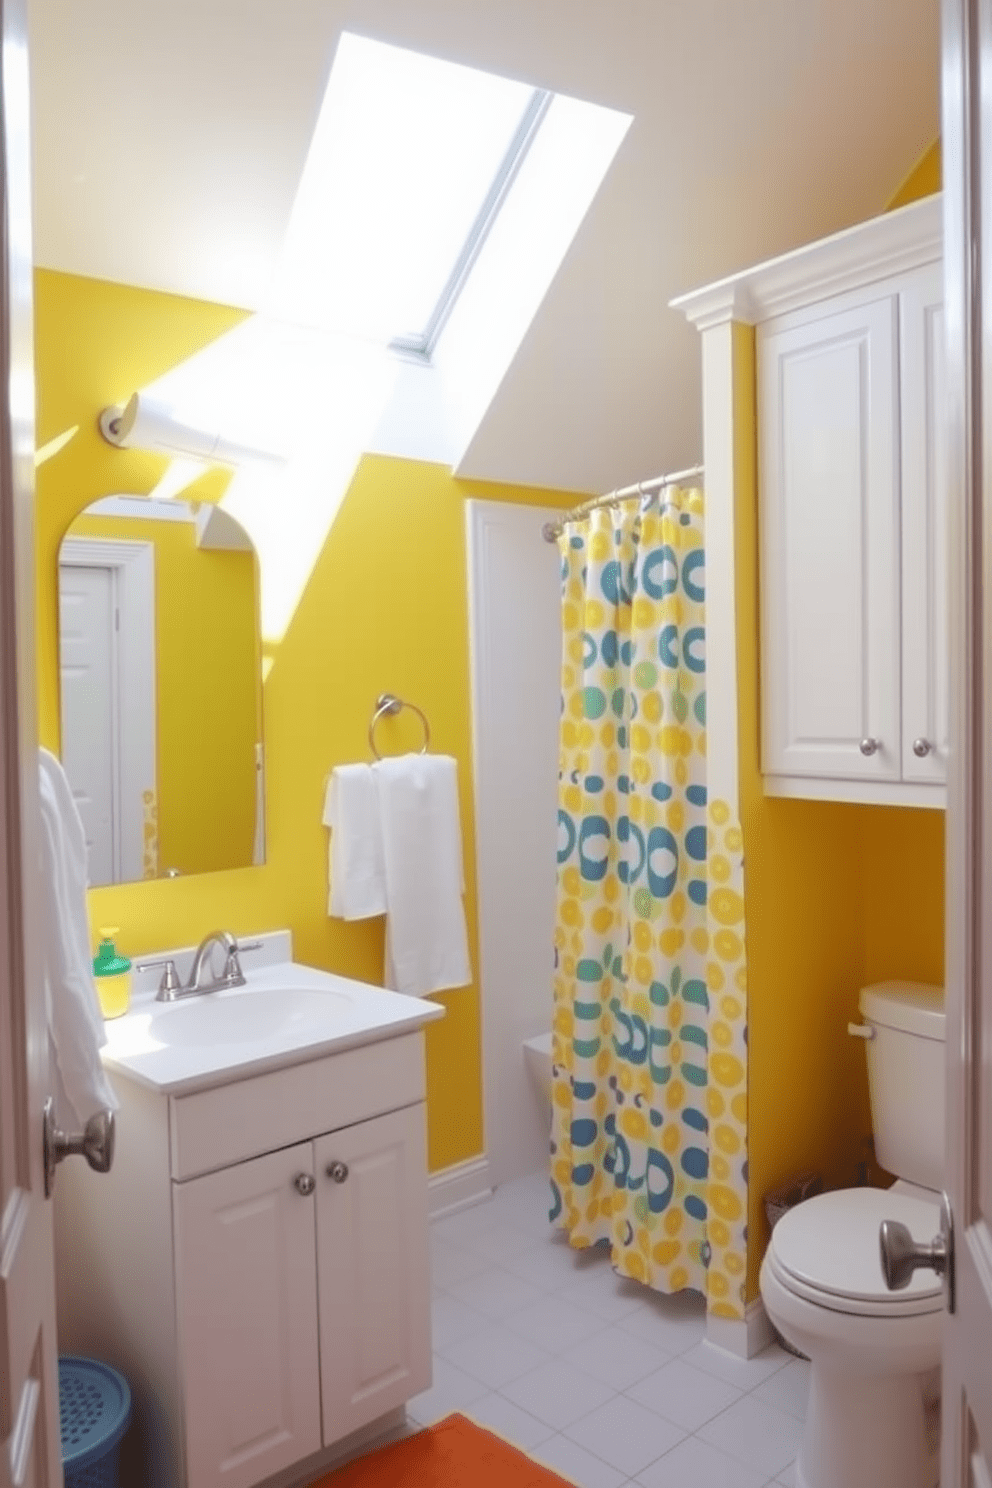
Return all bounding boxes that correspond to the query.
[36,264,576,1170]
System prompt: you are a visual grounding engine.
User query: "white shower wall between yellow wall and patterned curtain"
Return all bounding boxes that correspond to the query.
[467,501,561,1186]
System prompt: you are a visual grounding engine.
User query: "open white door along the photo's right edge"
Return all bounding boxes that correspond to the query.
[940,0,992,1488]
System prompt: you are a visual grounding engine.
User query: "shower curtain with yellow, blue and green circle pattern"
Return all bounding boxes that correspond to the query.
[552,487,747,1318]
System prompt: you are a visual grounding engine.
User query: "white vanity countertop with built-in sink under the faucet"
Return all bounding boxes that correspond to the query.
[103,937,445,1095]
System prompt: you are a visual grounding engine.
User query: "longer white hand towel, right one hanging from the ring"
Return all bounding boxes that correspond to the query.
[372,754,471,997]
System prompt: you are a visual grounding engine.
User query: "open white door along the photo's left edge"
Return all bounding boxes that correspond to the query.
[0,0,62,1488]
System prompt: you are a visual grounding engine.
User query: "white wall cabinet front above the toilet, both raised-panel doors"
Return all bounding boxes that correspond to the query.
[756,260,947,806]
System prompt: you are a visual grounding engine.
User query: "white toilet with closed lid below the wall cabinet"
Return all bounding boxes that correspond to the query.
[760,982,944,1488]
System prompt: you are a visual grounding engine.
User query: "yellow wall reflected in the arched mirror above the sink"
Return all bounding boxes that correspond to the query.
[60,516,262,876]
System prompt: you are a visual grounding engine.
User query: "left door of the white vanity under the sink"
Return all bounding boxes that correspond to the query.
[173,1143,320,1488]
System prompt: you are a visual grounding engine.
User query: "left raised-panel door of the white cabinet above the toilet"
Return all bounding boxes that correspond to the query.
[757,293,901,781]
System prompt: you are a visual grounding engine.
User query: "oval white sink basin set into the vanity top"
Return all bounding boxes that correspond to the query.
[149,987,351,1048]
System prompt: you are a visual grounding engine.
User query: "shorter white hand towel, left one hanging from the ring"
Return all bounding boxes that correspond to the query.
[324,765,385,920]
